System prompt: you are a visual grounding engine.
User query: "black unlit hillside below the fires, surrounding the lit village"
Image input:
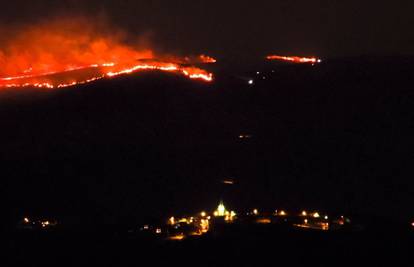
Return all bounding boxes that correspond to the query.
[0,57,414,266]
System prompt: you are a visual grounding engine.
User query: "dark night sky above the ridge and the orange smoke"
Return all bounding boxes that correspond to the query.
[0,0,414,57]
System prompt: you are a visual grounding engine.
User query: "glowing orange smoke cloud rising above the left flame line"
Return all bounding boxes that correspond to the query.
[0,17,154,77]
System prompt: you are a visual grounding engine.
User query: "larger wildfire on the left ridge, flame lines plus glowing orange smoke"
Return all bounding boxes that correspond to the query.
[0,18,215,88]
